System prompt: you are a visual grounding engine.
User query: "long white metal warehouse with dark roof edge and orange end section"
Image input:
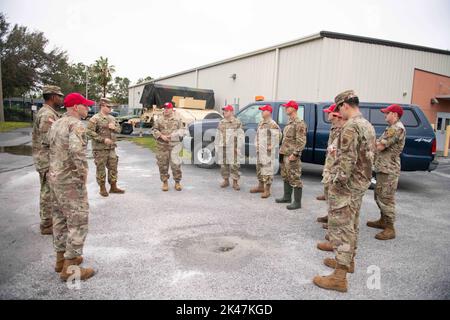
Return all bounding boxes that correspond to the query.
[129,31,450,144]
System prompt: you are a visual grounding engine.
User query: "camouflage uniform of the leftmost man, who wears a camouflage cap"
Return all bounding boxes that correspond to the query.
[32,104,60,229]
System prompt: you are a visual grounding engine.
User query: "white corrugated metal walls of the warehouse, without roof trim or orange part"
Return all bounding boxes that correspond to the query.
[130,38,450,108]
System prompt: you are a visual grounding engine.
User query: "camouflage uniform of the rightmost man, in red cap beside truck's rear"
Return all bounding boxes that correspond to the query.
[375,120,406,224]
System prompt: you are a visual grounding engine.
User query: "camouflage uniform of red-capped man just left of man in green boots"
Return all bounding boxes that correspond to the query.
[256,119,281,185]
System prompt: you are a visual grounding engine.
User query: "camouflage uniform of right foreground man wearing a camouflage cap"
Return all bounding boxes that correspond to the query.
[328,114,375,268]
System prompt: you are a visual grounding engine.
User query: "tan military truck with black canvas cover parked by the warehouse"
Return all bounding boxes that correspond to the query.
[118,83,222,134]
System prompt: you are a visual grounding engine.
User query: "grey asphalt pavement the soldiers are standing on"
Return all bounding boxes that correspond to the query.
[0,128,450,299]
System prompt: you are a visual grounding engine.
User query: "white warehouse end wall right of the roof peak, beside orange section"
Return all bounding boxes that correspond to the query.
[315,38,450,103]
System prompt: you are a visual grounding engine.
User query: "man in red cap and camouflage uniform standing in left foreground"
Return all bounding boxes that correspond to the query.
[48,93,94,280]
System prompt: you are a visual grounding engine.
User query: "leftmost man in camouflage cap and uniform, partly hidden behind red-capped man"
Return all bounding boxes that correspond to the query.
[32,86,64,235]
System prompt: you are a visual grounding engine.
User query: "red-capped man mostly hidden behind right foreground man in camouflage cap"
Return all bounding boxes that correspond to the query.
[317,104,345,223]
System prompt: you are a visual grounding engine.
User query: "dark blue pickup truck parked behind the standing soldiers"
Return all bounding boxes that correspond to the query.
[183,101,438,171]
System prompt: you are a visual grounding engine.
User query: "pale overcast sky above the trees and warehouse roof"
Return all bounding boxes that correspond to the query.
[0,0,450,82]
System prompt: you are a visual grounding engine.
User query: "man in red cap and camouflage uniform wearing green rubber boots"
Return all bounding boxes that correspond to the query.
[275,100,307,210]
